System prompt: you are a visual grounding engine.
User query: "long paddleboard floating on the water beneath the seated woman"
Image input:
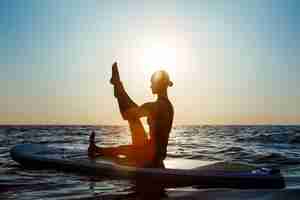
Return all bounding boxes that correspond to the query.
[10,144,285,189]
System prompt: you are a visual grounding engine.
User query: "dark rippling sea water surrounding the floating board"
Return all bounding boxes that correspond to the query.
[0,125,300,200]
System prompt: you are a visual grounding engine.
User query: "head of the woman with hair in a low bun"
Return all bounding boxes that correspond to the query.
[151,70,173,94]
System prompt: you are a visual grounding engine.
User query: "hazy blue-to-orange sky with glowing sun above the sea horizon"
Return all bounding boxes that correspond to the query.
[0,0,300,125]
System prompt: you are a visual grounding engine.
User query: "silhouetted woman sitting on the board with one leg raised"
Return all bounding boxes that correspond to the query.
[88,63,174,167]
